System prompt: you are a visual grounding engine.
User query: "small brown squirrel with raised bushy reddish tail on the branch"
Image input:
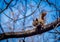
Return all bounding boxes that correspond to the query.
[33,12,47,27]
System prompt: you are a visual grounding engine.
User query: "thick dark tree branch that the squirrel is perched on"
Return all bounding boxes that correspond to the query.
[0,18,60,40]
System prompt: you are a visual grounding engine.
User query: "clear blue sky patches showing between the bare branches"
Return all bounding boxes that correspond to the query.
[0,0,60,42]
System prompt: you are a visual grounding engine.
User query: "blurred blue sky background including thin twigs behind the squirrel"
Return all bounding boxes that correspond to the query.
[0,0,60,42]
